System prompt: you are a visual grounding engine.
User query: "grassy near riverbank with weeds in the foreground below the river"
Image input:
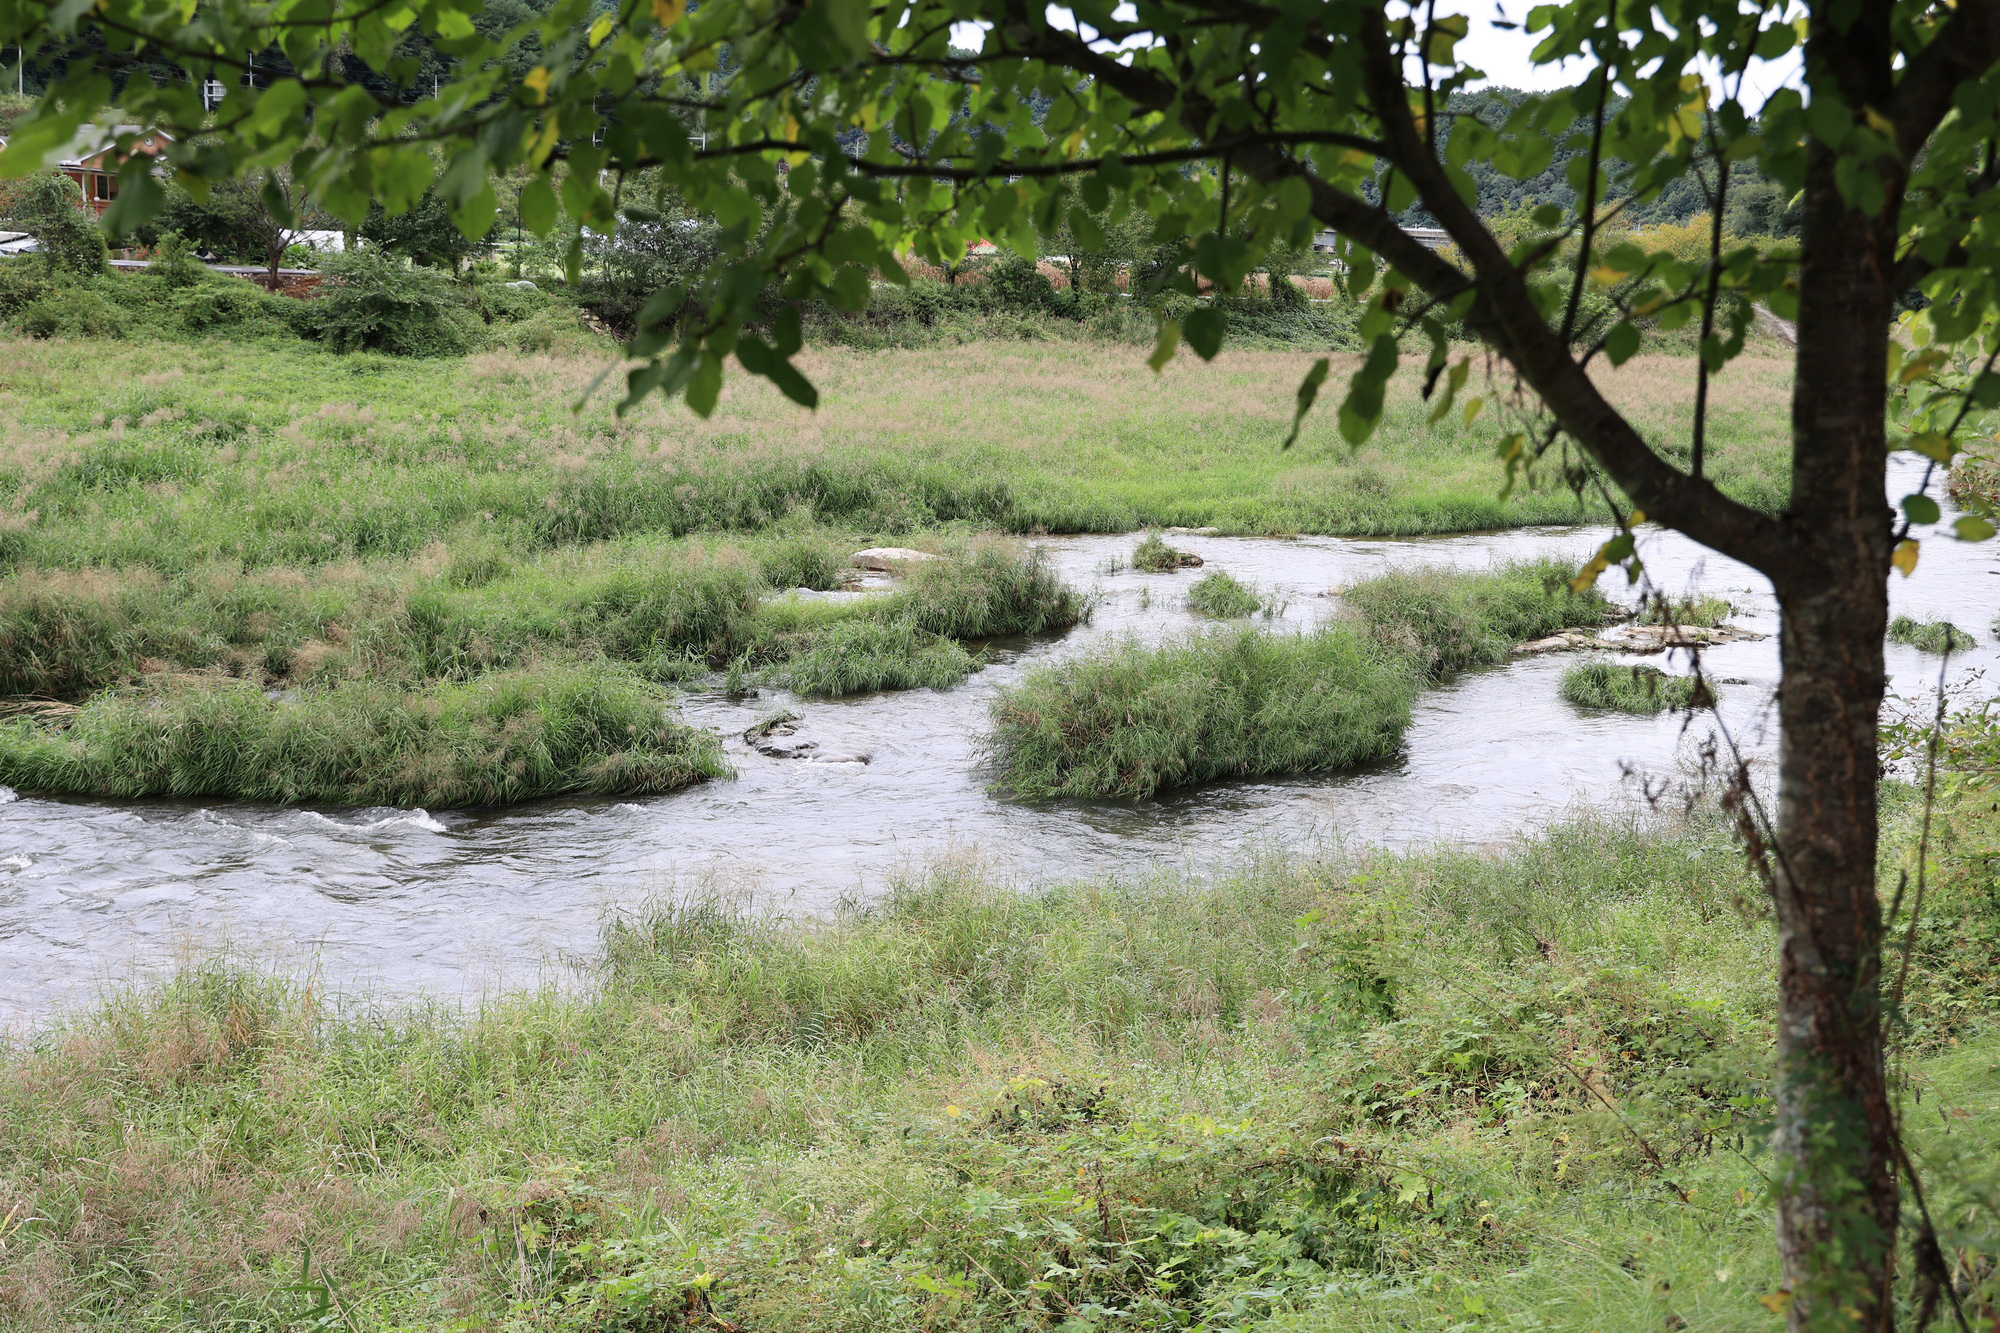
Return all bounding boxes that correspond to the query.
[0,800,2000,1333]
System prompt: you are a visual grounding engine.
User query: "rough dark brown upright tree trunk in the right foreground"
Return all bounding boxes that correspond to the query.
[1772,109,1900,1329]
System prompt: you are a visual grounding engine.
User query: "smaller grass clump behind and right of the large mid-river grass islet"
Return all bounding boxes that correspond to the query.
[1340,560,1612,675]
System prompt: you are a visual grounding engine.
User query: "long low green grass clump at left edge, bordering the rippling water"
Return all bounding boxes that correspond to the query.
[0,664,730,809]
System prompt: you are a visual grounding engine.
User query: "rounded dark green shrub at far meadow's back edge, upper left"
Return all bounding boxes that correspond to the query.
[308,250,472,356]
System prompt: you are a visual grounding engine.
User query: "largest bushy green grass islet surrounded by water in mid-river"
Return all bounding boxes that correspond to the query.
[990,626,1418,801]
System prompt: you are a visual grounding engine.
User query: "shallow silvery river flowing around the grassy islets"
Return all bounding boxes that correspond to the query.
[0,460,2000,1021]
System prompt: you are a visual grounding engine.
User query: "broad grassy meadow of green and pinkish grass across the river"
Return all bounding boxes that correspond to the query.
[0,338,1788,805]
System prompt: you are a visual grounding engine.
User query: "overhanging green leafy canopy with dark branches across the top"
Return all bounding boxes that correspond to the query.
[11,0,2000,568]
